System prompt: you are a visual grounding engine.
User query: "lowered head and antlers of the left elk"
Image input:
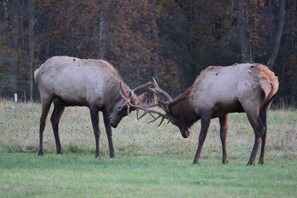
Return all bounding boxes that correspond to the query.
[110,83,151,128]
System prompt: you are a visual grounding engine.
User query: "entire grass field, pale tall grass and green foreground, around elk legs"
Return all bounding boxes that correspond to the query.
[0,101,297,197]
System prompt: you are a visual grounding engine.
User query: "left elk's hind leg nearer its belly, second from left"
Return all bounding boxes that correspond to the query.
[51,101,65,154]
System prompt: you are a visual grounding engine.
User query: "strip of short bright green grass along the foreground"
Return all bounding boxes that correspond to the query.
[0,153,297,197]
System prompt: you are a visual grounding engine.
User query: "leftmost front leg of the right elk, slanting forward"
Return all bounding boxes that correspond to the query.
[193,116,211,164]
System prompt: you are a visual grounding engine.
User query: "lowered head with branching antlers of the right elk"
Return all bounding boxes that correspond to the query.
[123,78,192,138]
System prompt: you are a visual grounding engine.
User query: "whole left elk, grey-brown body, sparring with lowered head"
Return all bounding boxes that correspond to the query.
[34,56,148,157]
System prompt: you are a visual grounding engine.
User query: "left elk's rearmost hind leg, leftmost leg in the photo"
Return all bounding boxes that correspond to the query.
[38,99,52,155]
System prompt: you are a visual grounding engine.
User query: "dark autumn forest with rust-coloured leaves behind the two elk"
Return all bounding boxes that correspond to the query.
[0,0,297,105]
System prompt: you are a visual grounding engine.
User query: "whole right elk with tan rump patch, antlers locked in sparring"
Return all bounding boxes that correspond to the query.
[122,63,279,165]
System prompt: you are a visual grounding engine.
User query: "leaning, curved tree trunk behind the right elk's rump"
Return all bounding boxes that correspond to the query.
[267,0,286,69]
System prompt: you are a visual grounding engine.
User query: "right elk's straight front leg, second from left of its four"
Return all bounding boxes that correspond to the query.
[219,114,229,164]
